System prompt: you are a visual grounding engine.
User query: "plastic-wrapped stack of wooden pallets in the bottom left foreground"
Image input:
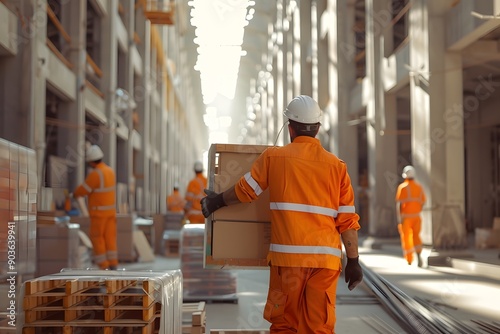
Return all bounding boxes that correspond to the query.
[23,270,182,334]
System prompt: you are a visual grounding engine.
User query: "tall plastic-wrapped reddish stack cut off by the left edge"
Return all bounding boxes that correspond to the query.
[0,139,39,324]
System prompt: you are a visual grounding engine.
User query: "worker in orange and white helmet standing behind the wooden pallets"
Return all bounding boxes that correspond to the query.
[73,145,118,270]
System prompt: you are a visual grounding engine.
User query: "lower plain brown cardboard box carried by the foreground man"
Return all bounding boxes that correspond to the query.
[212,221,271,260]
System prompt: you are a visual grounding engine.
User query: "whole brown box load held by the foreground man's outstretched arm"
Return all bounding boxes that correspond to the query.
[204,144,271,269]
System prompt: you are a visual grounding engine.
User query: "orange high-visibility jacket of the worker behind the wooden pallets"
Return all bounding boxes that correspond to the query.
[73,162,116,217]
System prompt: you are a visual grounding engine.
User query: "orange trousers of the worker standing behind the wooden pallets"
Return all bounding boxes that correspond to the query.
[90,216,118,269]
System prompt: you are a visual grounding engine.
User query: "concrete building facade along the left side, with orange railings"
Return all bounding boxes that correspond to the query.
[0,0,206,214]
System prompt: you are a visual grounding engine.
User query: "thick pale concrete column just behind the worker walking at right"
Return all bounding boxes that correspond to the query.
[410,0,466,249]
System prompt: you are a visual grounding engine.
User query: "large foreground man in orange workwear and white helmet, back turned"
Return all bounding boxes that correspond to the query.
[202,95,363,334]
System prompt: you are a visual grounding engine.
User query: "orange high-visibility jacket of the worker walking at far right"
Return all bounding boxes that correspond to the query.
[396,179,426,219]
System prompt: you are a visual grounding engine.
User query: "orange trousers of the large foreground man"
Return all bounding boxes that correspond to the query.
[264,265,340,334]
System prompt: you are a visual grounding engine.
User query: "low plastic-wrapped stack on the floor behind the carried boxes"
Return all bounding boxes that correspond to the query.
[180,224,238,302]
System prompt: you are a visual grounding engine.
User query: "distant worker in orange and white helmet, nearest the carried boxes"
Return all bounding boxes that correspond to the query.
[184,161,207,224]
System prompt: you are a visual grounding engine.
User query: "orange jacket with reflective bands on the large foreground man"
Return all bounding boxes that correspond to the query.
[235,136,360,270]
